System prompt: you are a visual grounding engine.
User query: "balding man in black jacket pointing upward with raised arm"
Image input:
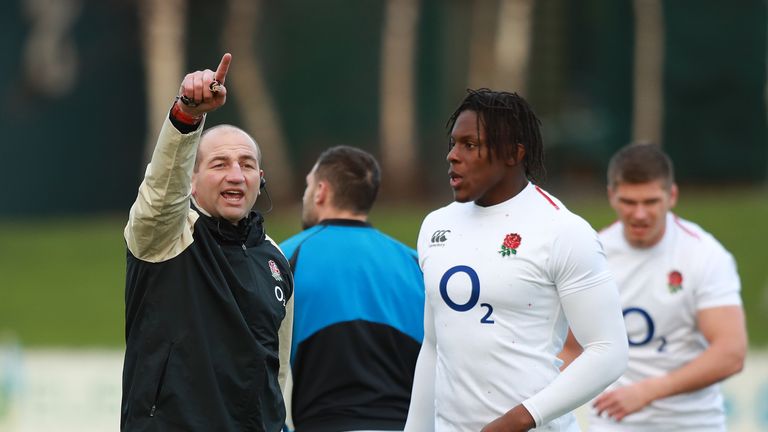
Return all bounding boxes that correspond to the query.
[120,54,293,432]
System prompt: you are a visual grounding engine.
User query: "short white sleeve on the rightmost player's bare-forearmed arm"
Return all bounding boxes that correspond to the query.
[695,238,741,309]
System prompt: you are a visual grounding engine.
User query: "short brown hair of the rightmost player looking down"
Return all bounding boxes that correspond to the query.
[608,142,675,189]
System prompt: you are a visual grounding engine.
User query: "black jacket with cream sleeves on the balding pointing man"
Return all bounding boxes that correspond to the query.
[120,116,293,432]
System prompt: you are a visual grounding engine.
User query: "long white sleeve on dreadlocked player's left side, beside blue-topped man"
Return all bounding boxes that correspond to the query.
[405,294,437,432]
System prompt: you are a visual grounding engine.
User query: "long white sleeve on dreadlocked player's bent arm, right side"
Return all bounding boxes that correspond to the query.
[523,214,628,426]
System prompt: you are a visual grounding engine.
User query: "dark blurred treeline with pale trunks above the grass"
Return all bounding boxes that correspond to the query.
[0,0,768,217]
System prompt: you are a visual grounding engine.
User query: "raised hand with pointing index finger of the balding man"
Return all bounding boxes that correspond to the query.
[177,53,232,117]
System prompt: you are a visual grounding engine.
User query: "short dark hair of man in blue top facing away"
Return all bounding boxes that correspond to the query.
[315,146,381,214]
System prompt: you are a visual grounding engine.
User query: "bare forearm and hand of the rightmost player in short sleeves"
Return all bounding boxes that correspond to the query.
[594,306,747,421]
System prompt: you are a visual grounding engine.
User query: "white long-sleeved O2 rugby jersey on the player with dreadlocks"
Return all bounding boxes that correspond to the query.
[406,184,627,432]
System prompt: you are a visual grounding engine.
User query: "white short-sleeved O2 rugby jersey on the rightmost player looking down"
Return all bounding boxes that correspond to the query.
[590,213,741,431]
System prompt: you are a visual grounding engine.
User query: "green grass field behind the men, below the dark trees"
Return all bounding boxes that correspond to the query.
[0,190,768,347]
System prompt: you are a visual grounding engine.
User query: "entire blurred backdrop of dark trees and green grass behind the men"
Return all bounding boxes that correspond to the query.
[0,0,768,346]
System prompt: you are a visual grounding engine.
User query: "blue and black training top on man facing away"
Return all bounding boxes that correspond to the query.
[280,219,424,432]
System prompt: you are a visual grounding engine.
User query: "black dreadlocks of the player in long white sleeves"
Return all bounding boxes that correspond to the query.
[446,88,546,183]
